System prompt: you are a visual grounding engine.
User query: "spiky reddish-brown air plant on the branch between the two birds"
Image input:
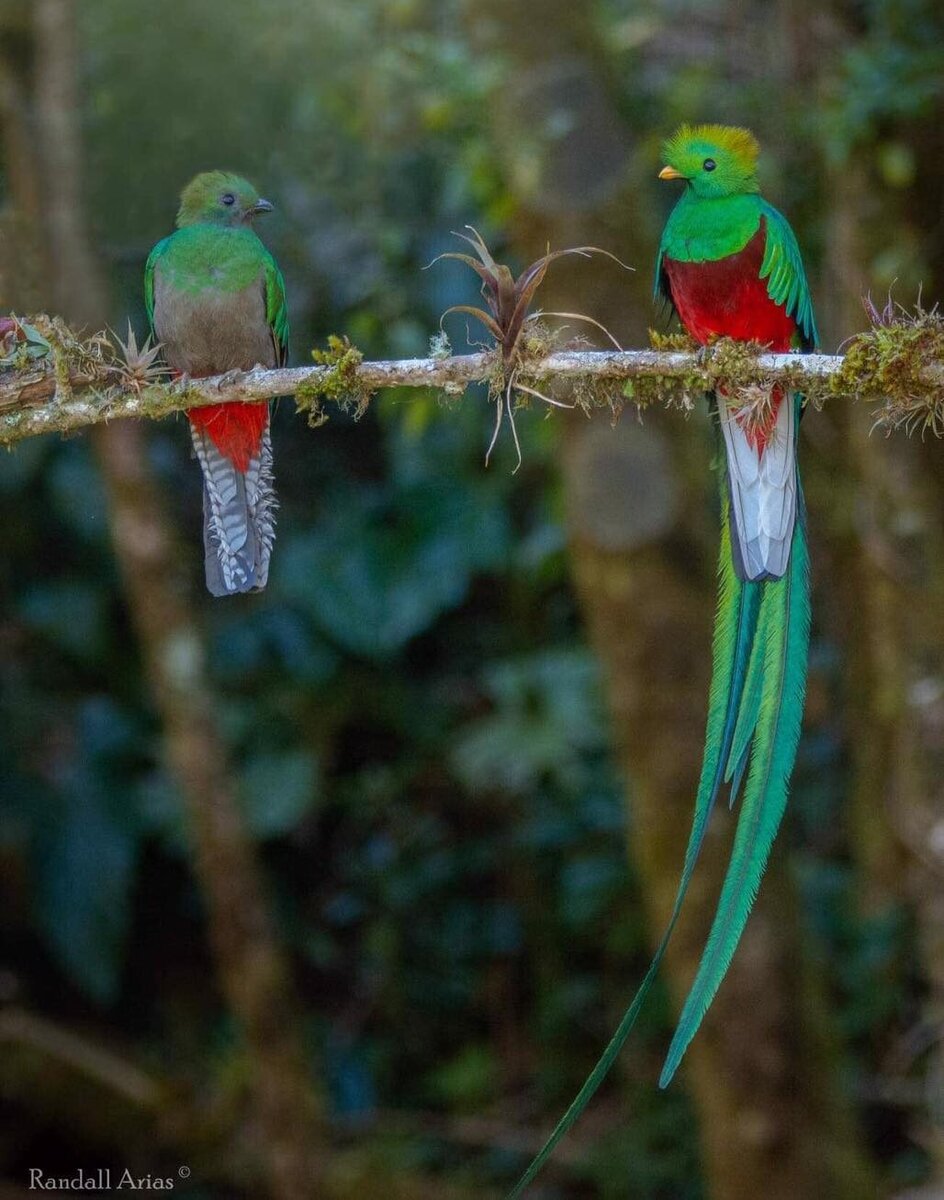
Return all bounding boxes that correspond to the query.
[429,226,632,472]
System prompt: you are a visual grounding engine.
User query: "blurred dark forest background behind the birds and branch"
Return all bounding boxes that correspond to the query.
[0,0,944,1200]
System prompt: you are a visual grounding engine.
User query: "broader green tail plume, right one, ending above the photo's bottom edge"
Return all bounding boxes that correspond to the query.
[660,499,810,1087]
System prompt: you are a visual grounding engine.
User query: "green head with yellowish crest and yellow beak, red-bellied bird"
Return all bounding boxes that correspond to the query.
[659,125,760,197]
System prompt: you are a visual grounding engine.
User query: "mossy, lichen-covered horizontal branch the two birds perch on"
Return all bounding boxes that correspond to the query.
[0,312,944,445]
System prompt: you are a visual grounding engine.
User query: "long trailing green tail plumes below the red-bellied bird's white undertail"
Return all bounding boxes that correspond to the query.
[507,406,810,1200]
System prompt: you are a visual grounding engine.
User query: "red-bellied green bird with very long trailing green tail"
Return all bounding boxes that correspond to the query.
[509,125,817,1200]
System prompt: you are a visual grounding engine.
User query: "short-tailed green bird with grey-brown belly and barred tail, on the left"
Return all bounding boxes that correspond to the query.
[144,170,288,596]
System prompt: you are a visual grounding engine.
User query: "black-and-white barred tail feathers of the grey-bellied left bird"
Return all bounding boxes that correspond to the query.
[191,421,276,596]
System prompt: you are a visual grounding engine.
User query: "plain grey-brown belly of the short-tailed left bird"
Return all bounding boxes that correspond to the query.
[154,272,276,376]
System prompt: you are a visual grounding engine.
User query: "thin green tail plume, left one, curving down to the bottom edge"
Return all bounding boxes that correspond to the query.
[509,473,763,1200]
